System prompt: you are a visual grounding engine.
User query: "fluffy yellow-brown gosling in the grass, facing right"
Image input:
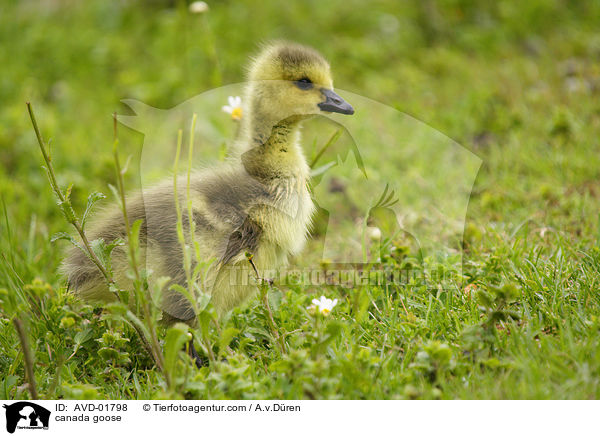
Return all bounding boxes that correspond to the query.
[64,42,354,330]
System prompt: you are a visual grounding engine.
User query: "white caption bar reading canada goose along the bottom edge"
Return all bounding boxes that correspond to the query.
[0,400,598,436]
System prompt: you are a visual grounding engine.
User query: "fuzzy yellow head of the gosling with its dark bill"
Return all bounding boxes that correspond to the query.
[248,42,354,125]
